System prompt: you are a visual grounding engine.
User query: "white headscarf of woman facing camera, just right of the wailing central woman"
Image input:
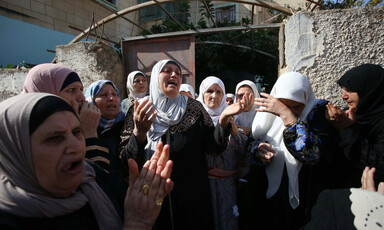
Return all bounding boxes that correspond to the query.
[197,76,228,125]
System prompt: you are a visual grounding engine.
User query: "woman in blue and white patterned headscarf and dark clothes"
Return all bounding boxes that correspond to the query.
[85,80,127,180]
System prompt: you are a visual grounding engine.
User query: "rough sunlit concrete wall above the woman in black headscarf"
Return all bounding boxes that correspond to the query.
[281,6,384,106]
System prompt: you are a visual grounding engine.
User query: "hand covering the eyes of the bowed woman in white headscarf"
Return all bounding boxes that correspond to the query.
[255,93,296,125]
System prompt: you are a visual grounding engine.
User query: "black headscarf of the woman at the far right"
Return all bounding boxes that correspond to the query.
[337,64,384,128]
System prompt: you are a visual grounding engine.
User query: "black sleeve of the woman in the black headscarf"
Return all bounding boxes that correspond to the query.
[340,124,384,178]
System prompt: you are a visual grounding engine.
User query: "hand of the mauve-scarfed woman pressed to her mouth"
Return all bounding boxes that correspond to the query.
[79,101,101,139]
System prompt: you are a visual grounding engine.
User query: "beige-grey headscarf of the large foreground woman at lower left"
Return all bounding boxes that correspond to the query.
[0,93,122,229]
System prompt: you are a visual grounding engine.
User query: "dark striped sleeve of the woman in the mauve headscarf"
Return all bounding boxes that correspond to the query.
[85,138,111,173]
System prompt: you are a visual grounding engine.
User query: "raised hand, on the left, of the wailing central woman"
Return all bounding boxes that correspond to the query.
[133,98,157,143]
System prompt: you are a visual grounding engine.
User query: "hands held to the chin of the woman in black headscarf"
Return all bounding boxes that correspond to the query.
[325,102,356,131]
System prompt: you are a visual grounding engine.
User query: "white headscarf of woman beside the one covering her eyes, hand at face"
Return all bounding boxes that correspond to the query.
[235,80,260,128]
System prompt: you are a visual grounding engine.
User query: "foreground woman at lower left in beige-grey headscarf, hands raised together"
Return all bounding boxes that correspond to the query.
[0,93,173,229]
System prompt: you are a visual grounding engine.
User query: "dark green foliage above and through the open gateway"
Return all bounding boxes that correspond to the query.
[138,0,282,92]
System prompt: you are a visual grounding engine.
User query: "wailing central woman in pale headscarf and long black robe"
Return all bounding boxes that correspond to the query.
[121,60,229,229]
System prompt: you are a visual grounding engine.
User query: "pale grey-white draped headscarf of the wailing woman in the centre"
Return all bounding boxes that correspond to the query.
[140,60,188,159]
